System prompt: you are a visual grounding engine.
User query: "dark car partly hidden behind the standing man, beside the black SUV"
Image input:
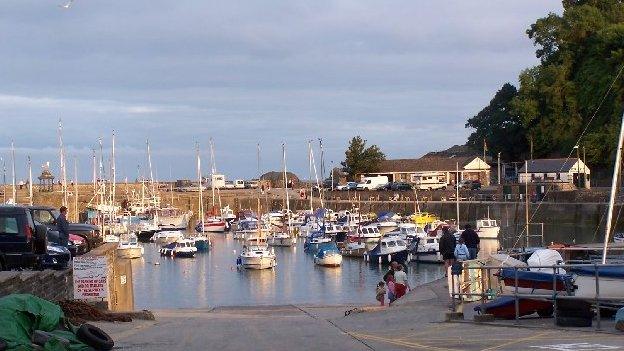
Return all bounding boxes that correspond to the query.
[28,206,103,254]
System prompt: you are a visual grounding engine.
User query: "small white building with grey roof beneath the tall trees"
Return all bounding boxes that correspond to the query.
[518,158,591,189]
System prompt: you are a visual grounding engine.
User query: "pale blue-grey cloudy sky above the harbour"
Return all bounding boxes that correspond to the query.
[0,0,562,180]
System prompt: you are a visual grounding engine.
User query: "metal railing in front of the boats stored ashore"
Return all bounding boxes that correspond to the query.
[451,263,624,330]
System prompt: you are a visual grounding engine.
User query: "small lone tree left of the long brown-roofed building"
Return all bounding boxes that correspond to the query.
[341,135,386,180]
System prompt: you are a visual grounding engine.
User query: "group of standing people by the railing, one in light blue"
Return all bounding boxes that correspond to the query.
[439,224,481,270]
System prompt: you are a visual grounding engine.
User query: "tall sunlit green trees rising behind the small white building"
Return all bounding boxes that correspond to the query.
[511,0,624,166]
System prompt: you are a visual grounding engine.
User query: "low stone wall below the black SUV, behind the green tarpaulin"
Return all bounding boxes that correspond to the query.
[0,269,74,301]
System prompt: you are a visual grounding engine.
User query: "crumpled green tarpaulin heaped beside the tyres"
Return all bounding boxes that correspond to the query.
[0,294,92,351]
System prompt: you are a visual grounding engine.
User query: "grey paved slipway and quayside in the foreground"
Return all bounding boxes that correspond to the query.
[99,281,624,351]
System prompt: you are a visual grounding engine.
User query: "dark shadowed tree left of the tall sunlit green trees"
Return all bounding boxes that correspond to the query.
[466,83,528,161]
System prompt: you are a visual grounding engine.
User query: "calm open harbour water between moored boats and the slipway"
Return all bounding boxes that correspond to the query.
[132,234,444,309]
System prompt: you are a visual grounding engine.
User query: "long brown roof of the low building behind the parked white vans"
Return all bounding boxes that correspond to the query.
[375,156,476,173]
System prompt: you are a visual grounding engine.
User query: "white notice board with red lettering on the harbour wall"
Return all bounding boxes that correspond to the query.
[73,256,108,300]
